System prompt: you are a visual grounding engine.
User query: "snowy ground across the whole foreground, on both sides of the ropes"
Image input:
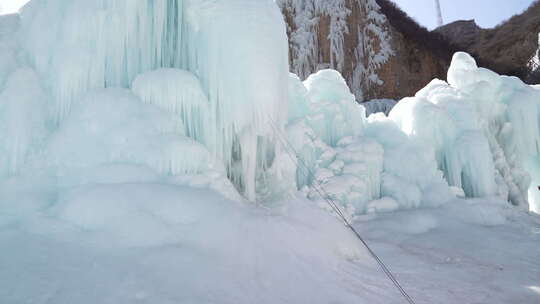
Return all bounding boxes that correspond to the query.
[0,189,540,304]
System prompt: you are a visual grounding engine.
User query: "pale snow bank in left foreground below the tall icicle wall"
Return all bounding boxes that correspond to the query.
[0,176,388,304]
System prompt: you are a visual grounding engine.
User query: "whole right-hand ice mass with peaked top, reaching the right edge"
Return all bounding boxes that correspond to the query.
[390,53,540,209]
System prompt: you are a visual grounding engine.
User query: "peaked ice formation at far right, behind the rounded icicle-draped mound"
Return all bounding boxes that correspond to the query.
[448,53,540,208]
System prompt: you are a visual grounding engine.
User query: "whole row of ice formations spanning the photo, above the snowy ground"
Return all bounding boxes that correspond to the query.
[0,0,540,215]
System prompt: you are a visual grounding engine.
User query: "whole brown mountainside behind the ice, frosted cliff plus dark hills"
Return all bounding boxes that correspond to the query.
[276,0,540,101]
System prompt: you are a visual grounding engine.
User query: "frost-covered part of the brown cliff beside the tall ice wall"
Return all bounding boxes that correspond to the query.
[276,0,395,100]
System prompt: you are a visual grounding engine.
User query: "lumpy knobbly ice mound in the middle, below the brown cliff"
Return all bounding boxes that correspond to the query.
[287,70,453,216]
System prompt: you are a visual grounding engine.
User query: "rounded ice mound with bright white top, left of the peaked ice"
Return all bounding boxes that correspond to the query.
[389,81,495,197]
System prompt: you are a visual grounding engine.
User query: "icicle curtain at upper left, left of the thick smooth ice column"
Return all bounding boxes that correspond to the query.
[21,0,183,122]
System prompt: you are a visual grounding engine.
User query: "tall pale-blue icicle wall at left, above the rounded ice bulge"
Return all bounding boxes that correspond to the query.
[13,0,288,200]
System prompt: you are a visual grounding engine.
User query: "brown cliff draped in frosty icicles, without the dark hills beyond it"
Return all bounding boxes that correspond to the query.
[277,0,451,101]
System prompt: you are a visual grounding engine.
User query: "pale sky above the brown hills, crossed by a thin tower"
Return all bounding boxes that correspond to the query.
[392,0,534,30]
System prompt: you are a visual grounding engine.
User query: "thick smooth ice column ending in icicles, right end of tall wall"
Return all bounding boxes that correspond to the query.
[183,0,289,200]
